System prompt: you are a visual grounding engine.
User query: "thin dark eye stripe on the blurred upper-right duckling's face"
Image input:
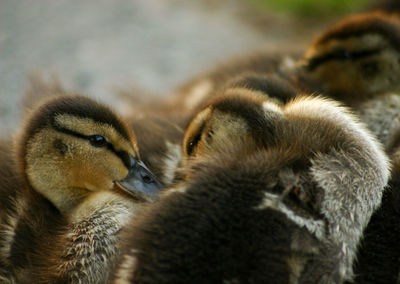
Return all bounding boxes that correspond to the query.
[307,48,382,71]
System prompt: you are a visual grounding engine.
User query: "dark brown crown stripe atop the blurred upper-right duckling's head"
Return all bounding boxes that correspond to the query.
[314,13,400,51]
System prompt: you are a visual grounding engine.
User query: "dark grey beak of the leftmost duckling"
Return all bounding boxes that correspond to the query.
[117,156,162,199]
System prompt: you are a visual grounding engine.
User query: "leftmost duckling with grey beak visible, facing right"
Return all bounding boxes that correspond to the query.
[0,95,160,283]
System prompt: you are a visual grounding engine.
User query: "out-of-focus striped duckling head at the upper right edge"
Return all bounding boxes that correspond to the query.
[303,12,400,104]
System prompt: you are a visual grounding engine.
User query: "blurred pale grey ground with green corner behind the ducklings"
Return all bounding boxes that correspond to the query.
[0,0,381,137]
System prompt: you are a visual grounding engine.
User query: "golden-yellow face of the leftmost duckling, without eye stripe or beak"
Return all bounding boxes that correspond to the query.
[26,114,138,213]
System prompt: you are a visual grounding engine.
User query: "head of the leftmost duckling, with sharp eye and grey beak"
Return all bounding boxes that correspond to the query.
[16,95,159,212]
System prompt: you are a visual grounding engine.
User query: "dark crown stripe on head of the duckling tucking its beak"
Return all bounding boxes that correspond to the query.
[213,96,276,148]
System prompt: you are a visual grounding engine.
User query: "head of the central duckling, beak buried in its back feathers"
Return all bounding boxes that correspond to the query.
[183,87,282,161]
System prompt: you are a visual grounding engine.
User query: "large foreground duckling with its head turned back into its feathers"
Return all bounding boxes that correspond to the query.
[112,92,389,284]
